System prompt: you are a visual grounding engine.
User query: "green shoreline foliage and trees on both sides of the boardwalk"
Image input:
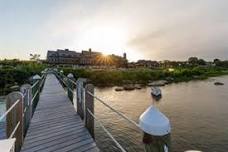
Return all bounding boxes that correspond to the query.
[0,57,228,94]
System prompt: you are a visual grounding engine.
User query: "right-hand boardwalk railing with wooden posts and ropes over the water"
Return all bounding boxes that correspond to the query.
[55,72,140,152]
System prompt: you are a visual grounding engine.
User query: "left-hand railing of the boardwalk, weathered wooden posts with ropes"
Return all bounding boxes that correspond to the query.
[0,74,45,152]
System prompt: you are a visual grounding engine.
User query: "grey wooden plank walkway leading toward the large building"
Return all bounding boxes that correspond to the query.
[21,74,99,152]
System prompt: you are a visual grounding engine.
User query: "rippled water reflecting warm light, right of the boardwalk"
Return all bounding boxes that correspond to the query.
[95,76,228,152]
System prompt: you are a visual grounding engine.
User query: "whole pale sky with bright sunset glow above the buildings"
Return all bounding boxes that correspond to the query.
[0,0,228,61]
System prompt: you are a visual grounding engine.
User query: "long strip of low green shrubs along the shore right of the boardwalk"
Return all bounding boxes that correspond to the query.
[62,66,228,86]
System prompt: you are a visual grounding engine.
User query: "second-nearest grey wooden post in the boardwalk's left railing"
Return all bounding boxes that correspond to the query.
[20,84,32,137]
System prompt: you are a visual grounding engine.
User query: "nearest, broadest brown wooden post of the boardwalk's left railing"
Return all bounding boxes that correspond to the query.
[6,91,24,152]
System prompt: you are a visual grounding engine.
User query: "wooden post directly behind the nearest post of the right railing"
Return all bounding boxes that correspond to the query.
[76,78,86,120]
